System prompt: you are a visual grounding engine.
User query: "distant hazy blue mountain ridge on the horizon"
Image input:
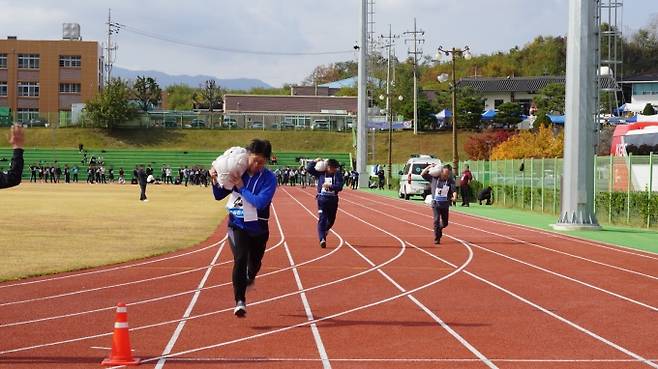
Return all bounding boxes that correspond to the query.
[112,66,272,90]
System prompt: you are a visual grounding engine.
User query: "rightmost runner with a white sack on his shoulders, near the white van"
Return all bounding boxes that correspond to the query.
[420,164,457,245]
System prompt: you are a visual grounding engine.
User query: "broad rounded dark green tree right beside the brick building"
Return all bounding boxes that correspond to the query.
[85,78,137,129]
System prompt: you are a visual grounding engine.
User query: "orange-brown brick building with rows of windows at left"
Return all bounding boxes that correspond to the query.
[0,37,103,124]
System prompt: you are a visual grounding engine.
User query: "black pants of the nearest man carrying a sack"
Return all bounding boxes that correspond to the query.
[228,227,270,302]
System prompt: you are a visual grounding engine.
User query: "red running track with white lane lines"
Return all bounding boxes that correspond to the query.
[0,187,658,369]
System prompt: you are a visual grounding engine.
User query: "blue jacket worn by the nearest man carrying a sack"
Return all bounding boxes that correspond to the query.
[211,168,276,235]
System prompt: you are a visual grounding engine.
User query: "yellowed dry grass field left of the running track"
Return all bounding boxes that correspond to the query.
[0,183,226,281]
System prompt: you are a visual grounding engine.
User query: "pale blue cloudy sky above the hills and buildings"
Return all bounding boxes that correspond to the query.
[0,0,658,85]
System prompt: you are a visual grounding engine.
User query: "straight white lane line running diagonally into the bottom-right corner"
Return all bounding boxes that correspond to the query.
[407,236,658,369]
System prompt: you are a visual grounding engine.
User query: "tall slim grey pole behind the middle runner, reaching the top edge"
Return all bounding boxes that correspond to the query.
[356,0,370,188]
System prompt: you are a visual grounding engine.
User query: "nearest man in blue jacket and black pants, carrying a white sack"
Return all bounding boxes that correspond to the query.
[210,139,276,317]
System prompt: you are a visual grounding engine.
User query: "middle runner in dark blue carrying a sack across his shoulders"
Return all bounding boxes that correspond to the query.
[306,158,344,248]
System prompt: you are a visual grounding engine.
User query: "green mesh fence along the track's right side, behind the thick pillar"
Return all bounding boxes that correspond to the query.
[460,154,658,228]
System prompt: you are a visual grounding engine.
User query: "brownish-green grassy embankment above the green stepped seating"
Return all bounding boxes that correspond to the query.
[0,128,471,164]
